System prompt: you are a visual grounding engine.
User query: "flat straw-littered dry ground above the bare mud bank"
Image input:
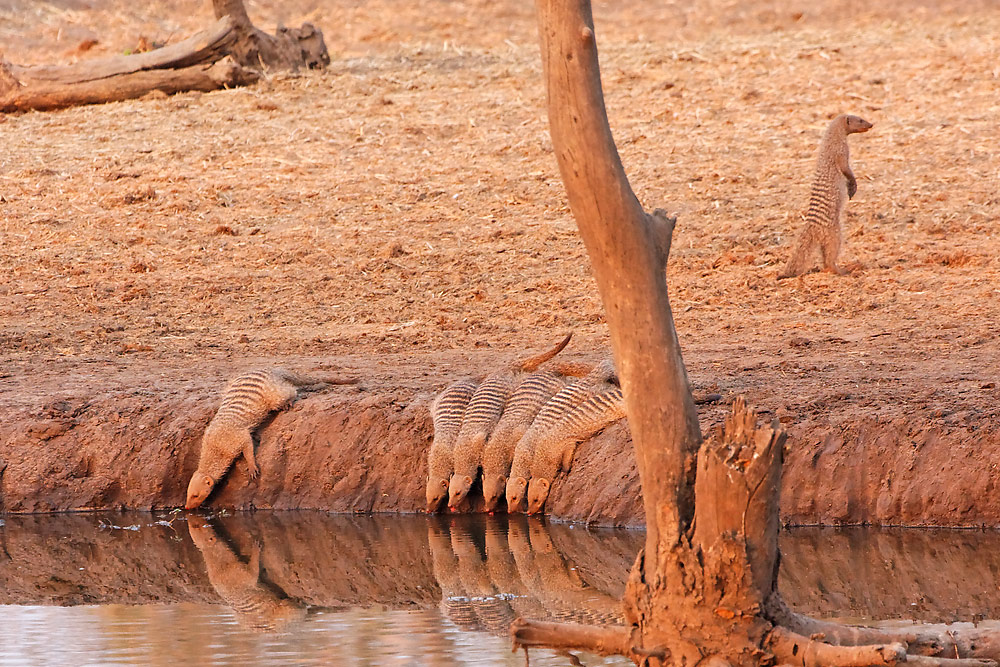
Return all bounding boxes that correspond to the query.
[0,0,1000,418]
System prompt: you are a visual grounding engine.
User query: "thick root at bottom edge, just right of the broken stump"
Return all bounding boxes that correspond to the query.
[765,626,906,667]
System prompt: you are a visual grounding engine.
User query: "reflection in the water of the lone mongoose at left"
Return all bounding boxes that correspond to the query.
[188,517,306,632]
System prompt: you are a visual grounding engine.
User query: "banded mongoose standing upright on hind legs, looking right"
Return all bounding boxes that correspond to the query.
[778,114,872,278]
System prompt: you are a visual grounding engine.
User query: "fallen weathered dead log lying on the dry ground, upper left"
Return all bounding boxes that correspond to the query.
[0,0,330,112]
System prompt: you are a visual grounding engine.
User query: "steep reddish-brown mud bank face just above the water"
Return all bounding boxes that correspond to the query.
[0,378,1000,527]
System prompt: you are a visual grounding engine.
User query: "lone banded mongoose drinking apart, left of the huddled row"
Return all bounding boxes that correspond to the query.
[184,368,358,510]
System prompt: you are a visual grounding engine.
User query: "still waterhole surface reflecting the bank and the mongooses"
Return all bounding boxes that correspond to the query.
[0,512,1000,667]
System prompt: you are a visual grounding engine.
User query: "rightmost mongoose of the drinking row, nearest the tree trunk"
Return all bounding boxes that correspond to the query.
[524,383,625,514]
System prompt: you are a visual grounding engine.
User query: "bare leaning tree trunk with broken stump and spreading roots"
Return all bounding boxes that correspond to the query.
[511,0,997,667]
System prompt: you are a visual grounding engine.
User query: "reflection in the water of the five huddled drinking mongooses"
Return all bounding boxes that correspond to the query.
[428,516,624,635]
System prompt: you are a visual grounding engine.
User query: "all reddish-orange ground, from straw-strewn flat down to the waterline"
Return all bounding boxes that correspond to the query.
[0,0,1000,526]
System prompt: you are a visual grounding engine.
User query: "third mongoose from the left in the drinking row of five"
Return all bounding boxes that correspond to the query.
[483,370,570,512]
